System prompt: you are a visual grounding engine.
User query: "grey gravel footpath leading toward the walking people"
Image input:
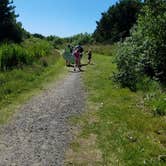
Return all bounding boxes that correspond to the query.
[0,72,84,166]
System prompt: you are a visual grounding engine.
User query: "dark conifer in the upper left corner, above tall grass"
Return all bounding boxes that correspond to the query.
[0,0,23,42]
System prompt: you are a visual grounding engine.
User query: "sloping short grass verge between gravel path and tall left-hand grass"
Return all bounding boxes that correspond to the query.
[0,51,65,124]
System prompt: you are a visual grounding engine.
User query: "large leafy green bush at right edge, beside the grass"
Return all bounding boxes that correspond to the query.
[115,0,166,90]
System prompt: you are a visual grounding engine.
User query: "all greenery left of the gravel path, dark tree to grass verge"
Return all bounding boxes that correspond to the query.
[0,0,64,124]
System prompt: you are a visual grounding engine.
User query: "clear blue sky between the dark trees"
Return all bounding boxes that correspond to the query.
[14,0,117,37]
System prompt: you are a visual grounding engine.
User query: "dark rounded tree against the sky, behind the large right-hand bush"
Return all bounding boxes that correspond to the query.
[93,0,142,42]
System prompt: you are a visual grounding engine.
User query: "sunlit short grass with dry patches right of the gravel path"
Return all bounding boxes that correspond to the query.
[66,54,166,166]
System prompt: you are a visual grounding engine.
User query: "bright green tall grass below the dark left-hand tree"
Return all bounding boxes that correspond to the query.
[0,38,53,71]
